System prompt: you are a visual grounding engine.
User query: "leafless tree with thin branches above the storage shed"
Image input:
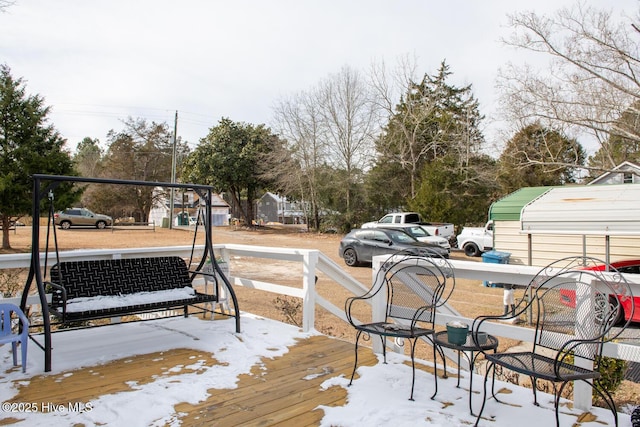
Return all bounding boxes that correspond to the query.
[498,3,640,171]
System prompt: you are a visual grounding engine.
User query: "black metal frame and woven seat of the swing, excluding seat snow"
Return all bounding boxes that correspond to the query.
[20,174,240,372]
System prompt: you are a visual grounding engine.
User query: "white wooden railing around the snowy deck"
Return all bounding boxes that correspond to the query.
[0,244,640,408]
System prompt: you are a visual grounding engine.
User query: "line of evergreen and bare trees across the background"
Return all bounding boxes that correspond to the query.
[0,4,640,251]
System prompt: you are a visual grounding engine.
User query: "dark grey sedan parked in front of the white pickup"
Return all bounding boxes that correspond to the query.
[338,228,449,266]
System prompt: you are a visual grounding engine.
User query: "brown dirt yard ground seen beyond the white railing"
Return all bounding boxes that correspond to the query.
[2,225,640,407]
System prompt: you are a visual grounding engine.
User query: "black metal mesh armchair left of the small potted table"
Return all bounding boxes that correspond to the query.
[345,254,455,400]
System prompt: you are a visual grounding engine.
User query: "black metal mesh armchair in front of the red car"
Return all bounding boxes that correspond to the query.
[472,256,633,426]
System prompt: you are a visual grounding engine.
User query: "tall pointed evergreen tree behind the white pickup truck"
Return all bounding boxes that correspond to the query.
[368,61,484,219]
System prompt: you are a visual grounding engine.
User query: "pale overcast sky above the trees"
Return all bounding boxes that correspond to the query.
[0,0,638,154]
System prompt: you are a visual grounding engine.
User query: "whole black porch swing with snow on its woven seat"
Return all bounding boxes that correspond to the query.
[20,174,240,372]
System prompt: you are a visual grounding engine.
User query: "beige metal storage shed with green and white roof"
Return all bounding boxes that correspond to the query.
[489,184,640,266]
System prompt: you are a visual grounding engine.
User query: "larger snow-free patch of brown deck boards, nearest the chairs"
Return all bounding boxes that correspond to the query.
[176,336,377,426]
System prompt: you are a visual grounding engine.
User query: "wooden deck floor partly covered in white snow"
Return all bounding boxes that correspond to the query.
[0,314,631,427]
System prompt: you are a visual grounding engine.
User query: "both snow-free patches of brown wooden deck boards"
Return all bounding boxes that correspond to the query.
[6,336,384,427]
